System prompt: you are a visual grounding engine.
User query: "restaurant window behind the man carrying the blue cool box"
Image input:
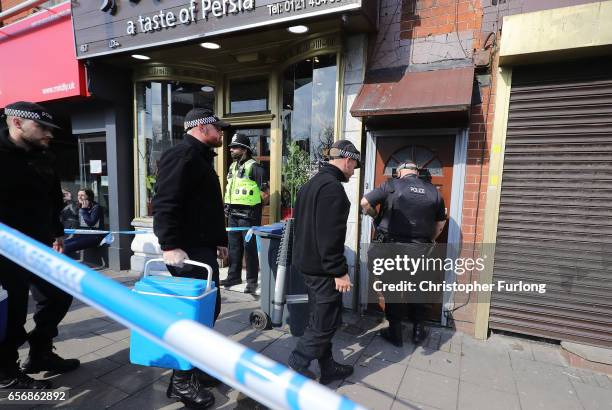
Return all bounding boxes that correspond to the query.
[136,81,215,217]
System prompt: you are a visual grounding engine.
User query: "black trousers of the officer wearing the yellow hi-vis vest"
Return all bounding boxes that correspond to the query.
[227,213,261,285]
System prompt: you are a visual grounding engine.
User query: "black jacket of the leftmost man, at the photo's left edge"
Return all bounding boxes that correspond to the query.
[0,126,64,245]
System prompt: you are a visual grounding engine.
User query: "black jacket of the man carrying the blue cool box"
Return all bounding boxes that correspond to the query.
[153,134,227,250]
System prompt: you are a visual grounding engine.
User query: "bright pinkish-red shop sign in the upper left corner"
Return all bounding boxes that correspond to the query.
[0,2,87,107]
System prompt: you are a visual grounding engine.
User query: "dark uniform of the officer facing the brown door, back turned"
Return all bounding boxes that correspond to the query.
[365,175,446,336]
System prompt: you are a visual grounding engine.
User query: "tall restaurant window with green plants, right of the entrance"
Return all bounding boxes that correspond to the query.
[281,54,338,218]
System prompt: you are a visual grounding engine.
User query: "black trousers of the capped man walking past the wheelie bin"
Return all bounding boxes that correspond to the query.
[295,275,342,366]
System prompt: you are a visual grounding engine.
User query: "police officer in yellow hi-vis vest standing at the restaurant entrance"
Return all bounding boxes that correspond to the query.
[221,134,268,293]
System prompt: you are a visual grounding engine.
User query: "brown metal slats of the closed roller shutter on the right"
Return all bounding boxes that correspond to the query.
[489,59,612,347]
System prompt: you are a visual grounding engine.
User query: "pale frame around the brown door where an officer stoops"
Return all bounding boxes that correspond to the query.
[359,128,468,326]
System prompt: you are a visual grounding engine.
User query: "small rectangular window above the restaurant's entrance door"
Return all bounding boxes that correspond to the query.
[229,78,268,114]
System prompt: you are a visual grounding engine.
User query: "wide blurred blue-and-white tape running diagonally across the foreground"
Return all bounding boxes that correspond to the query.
[0,223,364,410]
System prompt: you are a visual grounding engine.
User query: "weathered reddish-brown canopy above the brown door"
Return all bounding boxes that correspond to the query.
[351,67,474,117]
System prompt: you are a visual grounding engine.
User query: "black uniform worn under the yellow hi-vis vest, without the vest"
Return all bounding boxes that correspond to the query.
[225,160,267,290]
